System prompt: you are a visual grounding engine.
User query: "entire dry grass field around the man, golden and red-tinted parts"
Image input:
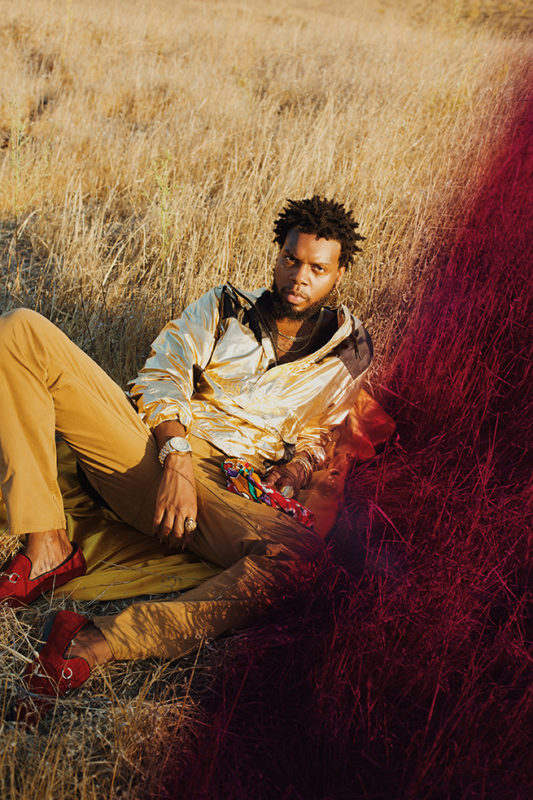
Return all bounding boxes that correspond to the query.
[0,0,533,800]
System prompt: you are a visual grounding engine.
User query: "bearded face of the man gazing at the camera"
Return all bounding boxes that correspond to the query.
[272,229,346,320]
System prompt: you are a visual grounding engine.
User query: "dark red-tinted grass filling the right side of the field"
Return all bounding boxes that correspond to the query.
[138,72,533,800]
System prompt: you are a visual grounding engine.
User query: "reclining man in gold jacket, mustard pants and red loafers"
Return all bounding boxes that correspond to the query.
[0,196,372,708]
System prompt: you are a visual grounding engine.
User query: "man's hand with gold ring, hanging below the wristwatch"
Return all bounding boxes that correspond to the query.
[153,453,197,550]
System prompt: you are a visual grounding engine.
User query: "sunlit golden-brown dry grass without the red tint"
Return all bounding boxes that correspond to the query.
[0,0,533,800]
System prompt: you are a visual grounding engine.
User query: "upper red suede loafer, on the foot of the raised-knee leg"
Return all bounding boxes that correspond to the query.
[0,543,87,608]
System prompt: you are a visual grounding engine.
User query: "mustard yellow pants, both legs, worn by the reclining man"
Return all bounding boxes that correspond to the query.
[0,309,324,659]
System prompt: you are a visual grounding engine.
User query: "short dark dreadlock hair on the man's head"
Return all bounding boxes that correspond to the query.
[274,194,365,267]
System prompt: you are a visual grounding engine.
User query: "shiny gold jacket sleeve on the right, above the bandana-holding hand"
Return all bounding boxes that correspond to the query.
[295,367,368,470]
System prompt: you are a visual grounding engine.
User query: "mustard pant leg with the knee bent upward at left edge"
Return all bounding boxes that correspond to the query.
[0,309,161,535]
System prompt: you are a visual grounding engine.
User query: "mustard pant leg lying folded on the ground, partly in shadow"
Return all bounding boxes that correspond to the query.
[93,439,325,659]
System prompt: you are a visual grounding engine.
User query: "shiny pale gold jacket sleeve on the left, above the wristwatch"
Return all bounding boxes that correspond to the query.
[129,287,222,429]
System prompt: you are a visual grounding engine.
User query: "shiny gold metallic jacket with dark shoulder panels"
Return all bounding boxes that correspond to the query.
[129,284,372,472]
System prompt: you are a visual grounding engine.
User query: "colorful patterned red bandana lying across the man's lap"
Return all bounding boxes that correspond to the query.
[222,458,315,528]
